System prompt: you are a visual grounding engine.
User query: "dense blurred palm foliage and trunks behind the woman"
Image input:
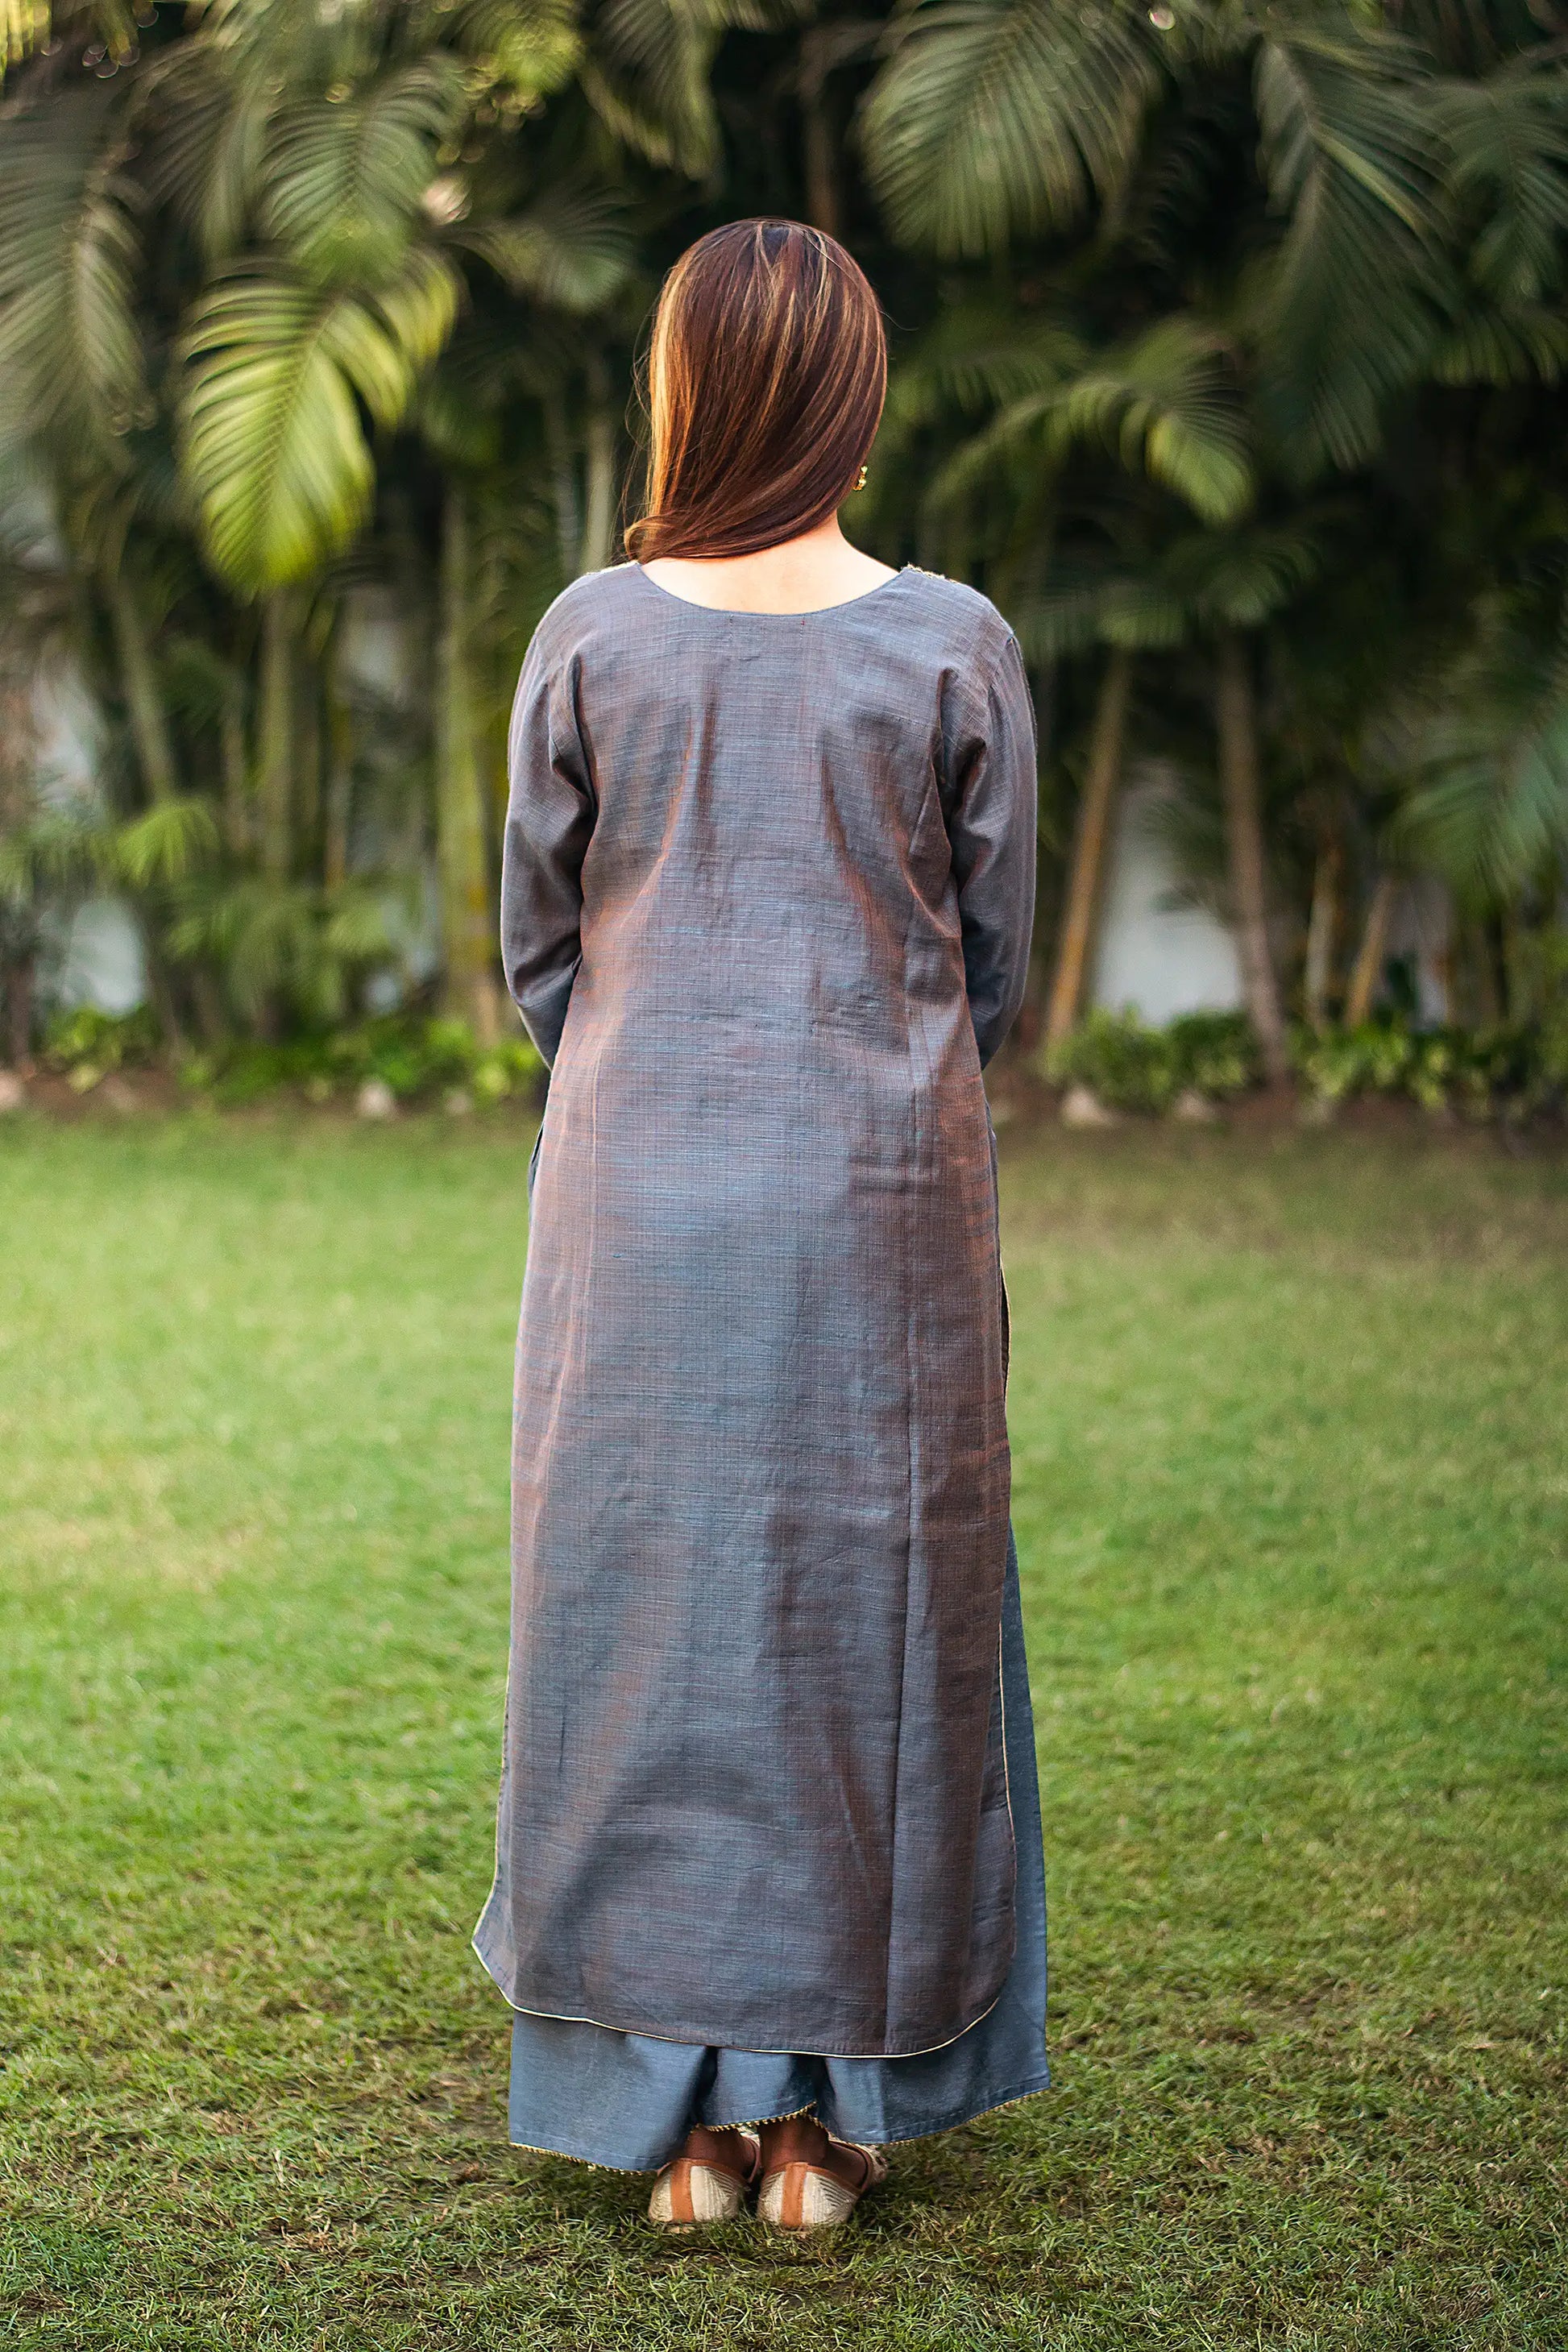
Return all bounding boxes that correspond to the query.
[0,0,1568,1103]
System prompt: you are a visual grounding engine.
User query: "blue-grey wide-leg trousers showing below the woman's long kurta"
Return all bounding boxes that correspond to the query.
[510,1524,1051,2173]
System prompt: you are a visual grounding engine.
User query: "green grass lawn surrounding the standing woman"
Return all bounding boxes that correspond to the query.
[0,1119,1568,2352]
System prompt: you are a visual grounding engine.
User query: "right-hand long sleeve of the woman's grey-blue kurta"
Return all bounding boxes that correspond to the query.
[948,630,1039,1068]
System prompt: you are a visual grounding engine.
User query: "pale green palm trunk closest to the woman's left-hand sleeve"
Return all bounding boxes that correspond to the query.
[435,482,499,1044]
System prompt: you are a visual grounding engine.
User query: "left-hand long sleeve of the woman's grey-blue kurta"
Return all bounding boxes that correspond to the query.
[500,637,597,1063]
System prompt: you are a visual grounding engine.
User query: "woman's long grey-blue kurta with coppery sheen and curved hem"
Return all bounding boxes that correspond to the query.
[475,565,1035,2055]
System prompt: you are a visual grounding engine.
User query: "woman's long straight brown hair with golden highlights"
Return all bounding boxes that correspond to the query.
[625,221,886,560]
